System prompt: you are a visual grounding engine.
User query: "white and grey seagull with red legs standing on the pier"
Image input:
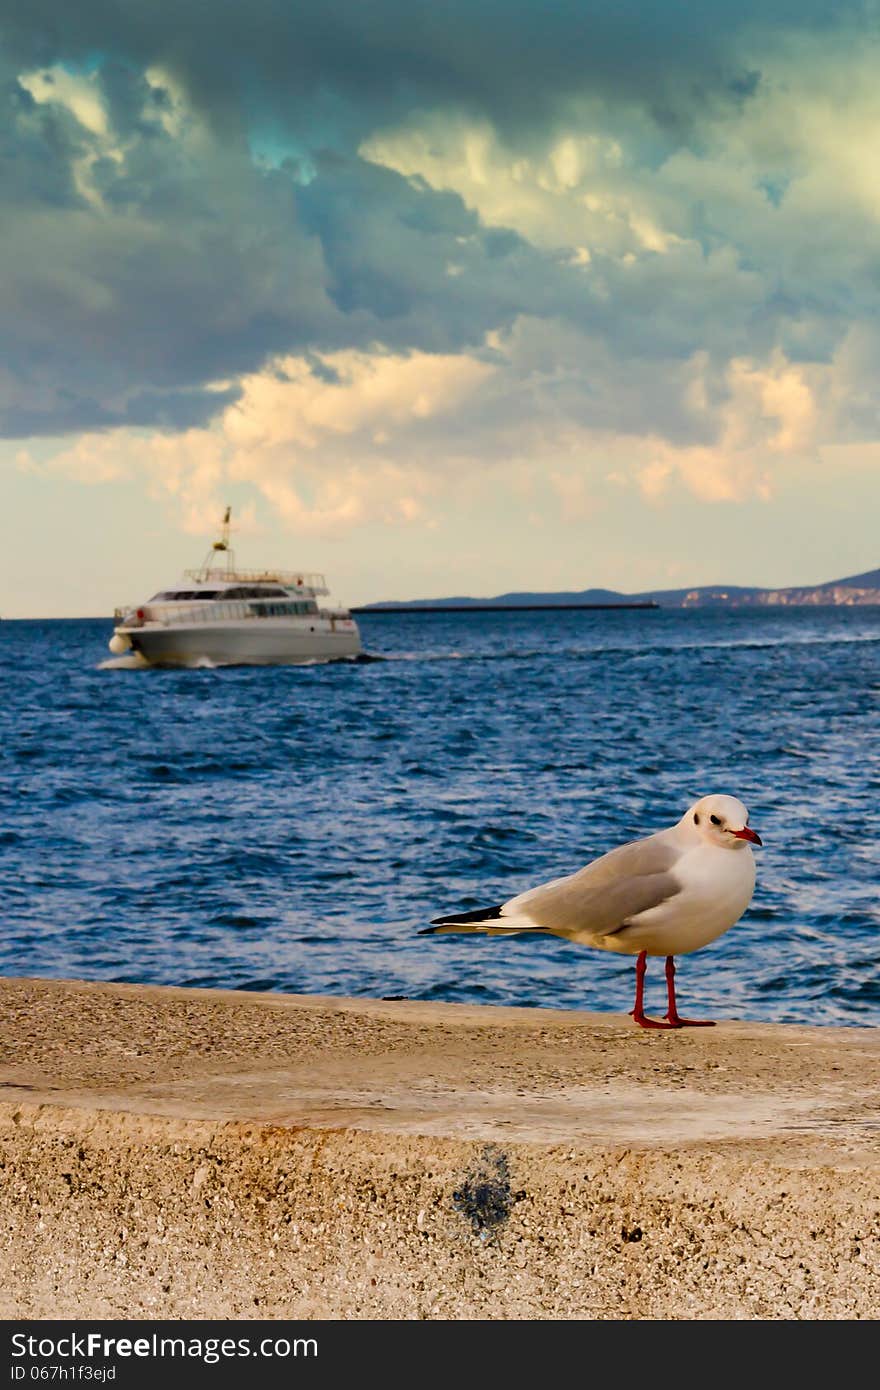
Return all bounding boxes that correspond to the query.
[420,795,762,1029]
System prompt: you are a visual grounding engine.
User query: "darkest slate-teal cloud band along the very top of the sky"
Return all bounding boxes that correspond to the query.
[3,0,872,142]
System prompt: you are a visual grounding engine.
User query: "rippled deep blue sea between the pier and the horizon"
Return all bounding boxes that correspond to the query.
[0,609,880,1024]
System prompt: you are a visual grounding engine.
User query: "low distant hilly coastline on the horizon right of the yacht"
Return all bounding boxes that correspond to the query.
[361,569,880,612]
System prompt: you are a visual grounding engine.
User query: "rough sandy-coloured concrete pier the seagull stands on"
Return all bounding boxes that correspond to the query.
[0,980,880,1319]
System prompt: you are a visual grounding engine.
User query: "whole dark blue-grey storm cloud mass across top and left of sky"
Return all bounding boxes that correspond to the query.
[0,0,867,436]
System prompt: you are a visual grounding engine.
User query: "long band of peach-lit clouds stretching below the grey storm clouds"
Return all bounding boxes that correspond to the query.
[19,320,833,537]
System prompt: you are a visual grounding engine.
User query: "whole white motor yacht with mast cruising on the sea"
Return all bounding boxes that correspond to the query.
[110,507,361,666]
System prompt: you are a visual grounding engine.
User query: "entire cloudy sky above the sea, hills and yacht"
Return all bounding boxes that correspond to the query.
[0,0,880,617]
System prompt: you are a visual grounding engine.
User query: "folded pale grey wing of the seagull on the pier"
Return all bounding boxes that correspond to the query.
[496,831,681,941]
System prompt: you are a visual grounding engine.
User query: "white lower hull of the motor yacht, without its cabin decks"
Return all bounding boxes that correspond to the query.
[115,621,363,666]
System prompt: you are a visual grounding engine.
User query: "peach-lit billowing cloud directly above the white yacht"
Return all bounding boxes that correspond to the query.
[27,352,496,535]
